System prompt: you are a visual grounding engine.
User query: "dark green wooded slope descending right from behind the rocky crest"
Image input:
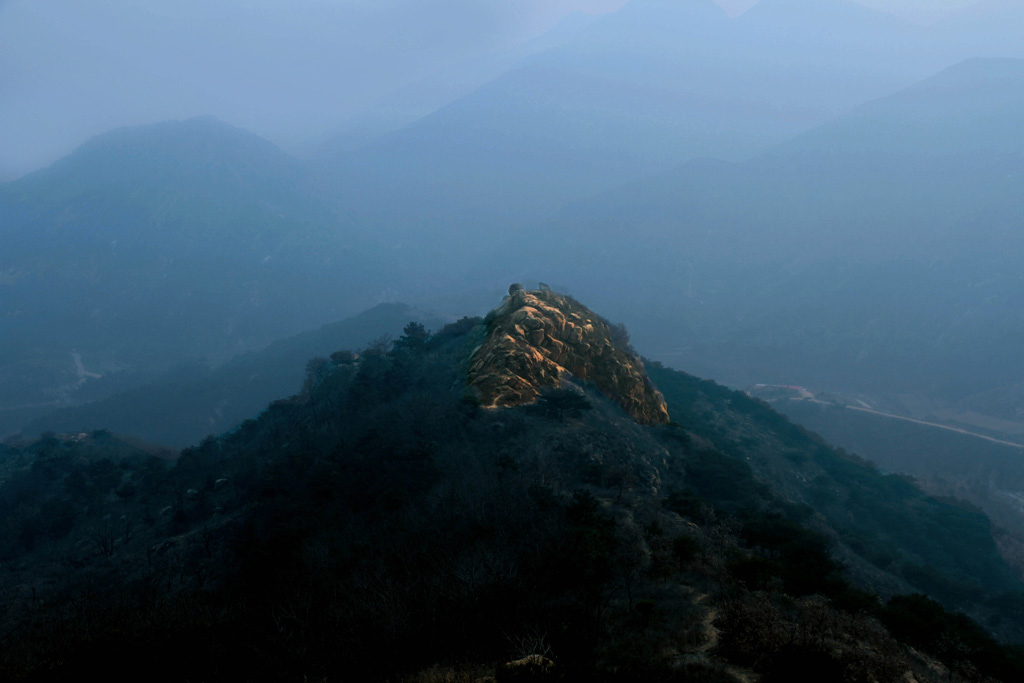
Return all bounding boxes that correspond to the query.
[650,365,1019,602]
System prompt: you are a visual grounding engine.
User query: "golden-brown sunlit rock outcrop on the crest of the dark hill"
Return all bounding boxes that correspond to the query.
[469,285,669,424]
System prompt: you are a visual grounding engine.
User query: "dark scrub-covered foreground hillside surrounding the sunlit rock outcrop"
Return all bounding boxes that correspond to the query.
[0,292,1024,682]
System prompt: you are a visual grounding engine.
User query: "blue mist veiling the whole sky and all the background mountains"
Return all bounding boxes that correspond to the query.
[0,0,1024,427]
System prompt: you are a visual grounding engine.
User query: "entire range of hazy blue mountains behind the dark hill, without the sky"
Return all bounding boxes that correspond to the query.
[0,0,1021,444]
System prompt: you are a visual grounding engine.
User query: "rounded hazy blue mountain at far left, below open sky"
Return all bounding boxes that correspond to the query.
[0,119,386,421]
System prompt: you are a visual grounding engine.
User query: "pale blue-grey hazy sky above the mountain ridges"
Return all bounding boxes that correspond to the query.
[0,0,991,180]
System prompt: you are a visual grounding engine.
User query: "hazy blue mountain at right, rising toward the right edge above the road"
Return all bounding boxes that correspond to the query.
[498,59,1024,417]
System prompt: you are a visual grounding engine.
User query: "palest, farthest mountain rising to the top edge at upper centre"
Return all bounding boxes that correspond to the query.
[317,0,958,248]
